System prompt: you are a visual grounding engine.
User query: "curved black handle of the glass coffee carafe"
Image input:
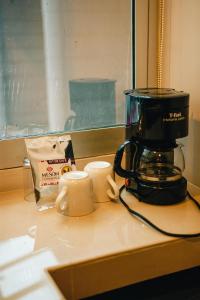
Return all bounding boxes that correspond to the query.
[114,140,138,178]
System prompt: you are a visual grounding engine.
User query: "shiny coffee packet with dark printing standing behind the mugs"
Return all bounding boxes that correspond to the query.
[25,135,76,210]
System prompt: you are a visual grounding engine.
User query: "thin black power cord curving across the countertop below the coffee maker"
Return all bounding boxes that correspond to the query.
[119,185,200,238]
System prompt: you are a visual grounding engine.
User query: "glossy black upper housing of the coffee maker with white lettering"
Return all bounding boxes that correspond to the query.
[125,88,189,141]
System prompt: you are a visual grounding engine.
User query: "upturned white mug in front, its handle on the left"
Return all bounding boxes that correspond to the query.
[56,171,94,217]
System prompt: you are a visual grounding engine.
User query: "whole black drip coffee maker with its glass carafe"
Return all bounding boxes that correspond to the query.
[114,88,189,205]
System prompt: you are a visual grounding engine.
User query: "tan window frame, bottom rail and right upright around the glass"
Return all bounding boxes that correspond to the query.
[0,0,157,170]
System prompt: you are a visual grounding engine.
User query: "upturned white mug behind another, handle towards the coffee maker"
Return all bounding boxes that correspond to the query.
[84,161,119,202]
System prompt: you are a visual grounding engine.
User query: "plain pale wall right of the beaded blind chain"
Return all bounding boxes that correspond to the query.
[163,0,200,185]
